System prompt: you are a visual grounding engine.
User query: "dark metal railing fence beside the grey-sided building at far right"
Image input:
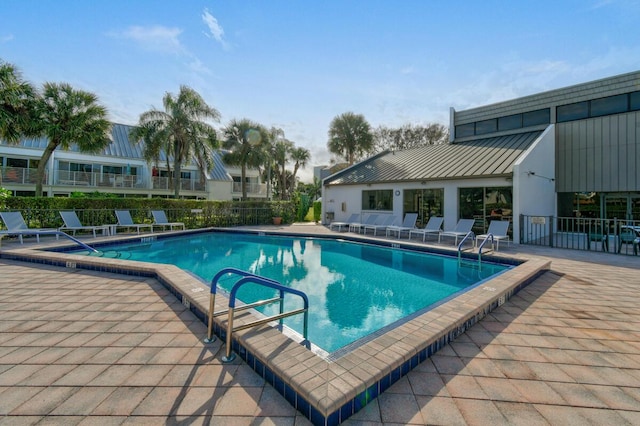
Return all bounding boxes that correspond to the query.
[520,215,640,255]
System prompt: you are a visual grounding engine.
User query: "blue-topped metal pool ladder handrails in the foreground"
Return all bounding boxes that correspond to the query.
[205,268,309,362]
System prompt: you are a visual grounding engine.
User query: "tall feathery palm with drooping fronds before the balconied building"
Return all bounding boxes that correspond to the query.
[131,86,220,198]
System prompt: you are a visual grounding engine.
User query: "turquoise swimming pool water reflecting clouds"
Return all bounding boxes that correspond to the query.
[82,232,509,353]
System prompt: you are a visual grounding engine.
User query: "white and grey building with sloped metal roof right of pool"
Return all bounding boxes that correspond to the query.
[322,71,640,242]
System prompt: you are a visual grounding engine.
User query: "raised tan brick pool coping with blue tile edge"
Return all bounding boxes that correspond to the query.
[0,228,550,425]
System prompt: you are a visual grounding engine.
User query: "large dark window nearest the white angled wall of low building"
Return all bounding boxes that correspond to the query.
[458,186,513,234]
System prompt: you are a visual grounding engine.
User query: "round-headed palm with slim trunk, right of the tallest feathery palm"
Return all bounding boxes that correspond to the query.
[222,118,270,201]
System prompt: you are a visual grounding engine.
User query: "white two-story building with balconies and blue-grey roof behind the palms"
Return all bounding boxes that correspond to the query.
[0,124,267,200]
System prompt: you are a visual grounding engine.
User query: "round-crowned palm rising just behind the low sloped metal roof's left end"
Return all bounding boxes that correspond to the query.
[327,112,373,165]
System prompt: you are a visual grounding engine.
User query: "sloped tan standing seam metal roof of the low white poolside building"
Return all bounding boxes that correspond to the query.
[325,131,542,185]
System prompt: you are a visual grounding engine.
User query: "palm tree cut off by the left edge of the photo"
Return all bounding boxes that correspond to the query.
[0,61,38,143]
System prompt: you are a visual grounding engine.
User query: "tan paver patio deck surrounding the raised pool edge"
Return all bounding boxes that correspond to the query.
[0,226,640,425]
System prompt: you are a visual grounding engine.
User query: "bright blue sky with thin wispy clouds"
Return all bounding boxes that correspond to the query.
[0,0,640,181]
